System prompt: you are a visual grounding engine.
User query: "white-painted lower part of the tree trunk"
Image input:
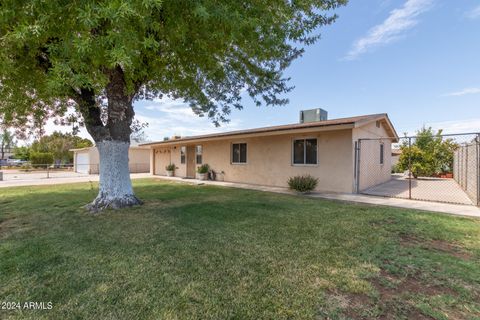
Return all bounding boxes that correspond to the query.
[86,140,142,212]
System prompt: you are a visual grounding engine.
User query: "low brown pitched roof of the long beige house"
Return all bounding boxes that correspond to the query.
[140,113,398,146]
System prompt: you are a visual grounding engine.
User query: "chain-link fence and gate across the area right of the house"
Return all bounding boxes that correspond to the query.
[354,133,480,206]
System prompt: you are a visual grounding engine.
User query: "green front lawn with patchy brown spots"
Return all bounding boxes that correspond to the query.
[0,179,480,319]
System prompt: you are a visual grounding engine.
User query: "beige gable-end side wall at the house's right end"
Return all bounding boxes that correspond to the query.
[352,121,392,191]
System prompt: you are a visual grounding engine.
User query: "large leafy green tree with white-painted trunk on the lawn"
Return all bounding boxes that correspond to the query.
[0,0,347,211]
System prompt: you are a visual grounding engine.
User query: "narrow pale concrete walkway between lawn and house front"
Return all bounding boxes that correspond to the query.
[154,176,480,218]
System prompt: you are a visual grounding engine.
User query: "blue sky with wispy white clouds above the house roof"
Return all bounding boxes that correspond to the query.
[51,0,480,140]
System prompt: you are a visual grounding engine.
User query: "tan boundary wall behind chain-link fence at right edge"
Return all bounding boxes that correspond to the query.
[453,143,480,206]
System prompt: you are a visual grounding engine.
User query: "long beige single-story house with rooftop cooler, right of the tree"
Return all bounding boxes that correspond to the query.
[142,114,398,193]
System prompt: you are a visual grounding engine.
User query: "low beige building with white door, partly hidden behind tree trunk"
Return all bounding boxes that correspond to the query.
[70,146,150,174]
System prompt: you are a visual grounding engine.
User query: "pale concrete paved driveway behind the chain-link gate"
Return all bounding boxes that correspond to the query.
[362,175,473,205]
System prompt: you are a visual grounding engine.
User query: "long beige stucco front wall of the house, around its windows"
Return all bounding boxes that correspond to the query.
[154,129,353,192]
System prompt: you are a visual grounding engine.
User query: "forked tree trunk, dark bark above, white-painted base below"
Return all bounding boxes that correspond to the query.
[76,67,142,212]
